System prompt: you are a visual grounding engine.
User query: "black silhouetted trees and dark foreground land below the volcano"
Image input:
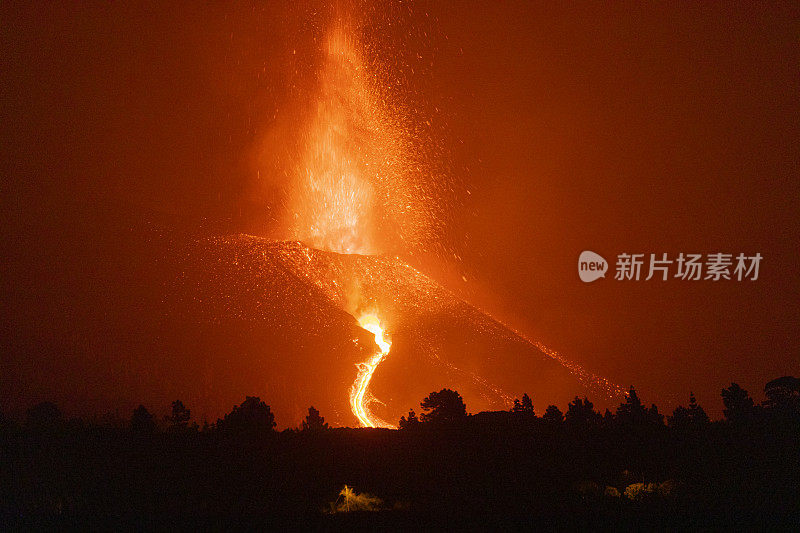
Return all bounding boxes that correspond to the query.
[0,376,800,529]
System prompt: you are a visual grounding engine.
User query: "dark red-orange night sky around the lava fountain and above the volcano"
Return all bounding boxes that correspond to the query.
[0,2,800,416]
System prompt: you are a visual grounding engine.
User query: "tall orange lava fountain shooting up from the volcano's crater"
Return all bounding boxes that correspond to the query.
[287,21,434,254]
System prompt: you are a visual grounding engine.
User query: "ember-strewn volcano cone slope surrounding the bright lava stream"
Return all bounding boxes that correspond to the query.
[167,235,620,426]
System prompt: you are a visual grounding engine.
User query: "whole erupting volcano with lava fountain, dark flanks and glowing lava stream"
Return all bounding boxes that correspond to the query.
[3,12,619,427]
